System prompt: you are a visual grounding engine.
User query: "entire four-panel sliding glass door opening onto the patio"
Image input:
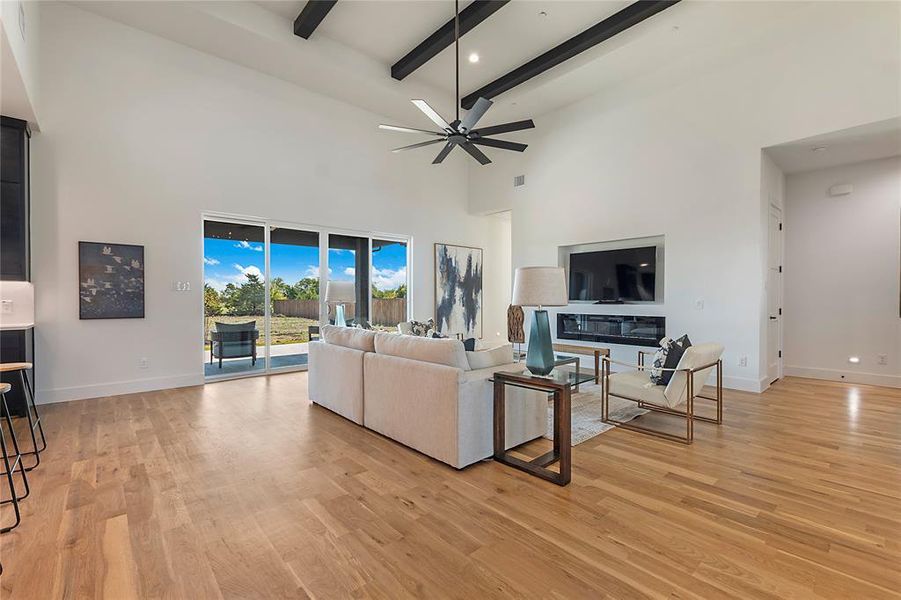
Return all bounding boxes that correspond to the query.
[203,215,410,380]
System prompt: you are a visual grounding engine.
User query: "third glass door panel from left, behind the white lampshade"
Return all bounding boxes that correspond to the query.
[325,233,369,326]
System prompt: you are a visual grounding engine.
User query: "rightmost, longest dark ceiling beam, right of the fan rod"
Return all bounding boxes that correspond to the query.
[460,0,679,110]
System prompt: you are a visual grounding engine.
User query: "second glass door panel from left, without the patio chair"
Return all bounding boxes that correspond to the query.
[269,226,319,369]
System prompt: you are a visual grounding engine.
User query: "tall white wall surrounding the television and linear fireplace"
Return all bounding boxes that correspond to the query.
[470,2,901,390]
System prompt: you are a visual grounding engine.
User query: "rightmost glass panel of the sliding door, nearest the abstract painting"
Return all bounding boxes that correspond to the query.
[371,238,407,331]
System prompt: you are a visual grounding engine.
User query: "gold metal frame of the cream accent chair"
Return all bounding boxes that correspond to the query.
[601,350,723,444]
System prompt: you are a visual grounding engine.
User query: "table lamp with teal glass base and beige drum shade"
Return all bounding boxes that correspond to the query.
[513,267,569,376]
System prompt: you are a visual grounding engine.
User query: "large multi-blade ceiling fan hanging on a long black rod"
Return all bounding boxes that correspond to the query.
[379,0,535,165]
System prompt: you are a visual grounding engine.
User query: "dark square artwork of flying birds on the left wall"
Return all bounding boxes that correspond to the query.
[78,242,144,319]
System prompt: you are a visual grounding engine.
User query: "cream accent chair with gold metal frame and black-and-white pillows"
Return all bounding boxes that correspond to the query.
[601,343,723,444]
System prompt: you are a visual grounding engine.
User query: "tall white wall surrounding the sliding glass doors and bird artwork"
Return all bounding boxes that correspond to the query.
[32,3,509,402]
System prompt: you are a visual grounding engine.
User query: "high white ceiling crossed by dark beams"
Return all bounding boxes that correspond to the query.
[74,0,809,126]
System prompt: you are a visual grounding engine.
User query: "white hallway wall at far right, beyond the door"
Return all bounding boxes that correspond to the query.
[784,158,901,387]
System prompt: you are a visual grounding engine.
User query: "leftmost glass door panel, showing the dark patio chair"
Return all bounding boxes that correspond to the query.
[203,220,266,377]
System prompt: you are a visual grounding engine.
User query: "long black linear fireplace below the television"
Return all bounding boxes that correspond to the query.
[557,313,666,346]
